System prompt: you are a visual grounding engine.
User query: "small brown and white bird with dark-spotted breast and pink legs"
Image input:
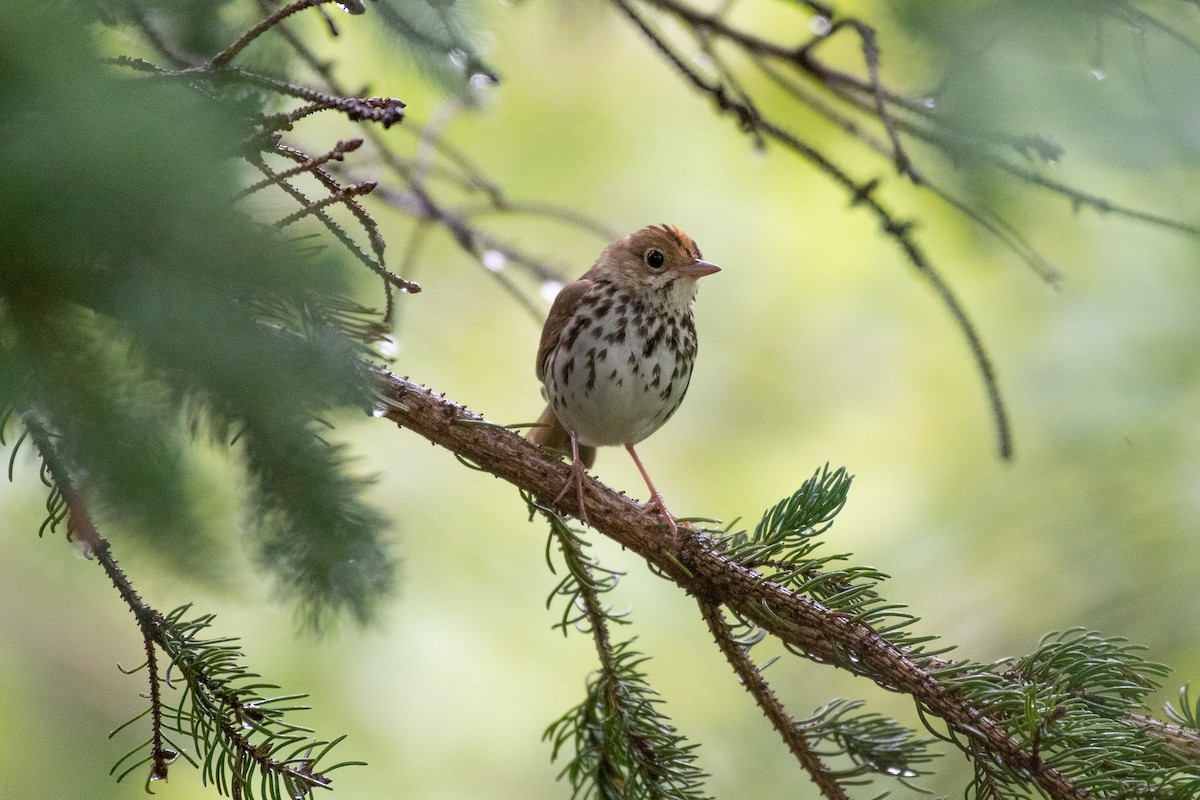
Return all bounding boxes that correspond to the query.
[528,225,720,534]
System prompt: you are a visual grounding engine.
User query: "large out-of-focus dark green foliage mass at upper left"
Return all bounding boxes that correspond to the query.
[0,4,392,625]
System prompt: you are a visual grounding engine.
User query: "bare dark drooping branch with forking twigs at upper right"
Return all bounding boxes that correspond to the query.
[610,0,1200,458]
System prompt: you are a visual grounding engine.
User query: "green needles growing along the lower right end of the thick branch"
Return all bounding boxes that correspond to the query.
[725,465,1200,800]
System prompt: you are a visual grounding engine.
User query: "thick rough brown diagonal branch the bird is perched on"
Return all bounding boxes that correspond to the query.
[378,369,1090,800]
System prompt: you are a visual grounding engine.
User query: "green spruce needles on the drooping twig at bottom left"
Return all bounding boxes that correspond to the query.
[110,606,360,800]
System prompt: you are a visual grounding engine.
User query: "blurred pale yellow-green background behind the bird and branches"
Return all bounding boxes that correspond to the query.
[0,2,1200,800]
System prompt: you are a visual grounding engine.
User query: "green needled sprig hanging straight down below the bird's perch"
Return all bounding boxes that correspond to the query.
[540,506,706,800]
